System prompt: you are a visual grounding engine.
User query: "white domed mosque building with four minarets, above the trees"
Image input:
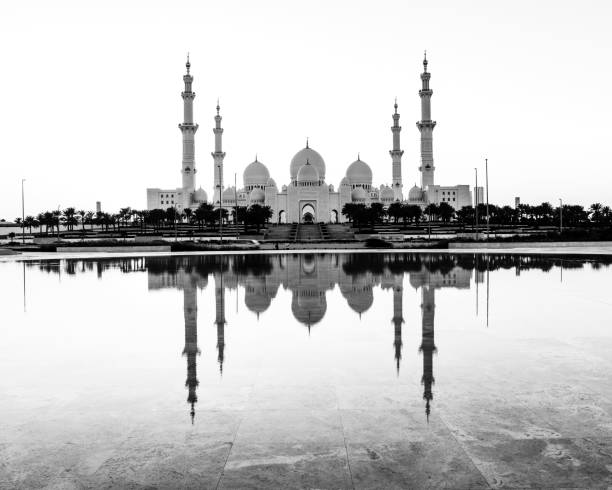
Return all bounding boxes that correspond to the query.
[147,53,472,223]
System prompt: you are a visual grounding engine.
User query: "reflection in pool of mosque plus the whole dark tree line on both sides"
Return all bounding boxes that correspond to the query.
[31,254,612,417]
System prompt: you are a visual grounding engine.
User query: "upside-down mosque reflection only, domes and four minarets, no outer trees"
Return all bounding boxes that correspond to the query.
[146,254,472,418]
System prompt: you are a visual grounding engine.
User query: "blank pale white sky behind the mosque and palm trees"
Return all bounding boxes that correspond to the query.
[0,0,612,220]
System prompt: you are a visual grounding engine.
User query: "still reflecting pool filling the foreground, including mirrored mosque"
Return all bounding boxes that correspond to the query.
[0,253,612,488]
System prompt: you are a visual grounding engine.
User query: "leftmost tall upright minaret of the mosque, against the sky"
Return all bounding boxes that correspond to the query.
[179,55,198,207]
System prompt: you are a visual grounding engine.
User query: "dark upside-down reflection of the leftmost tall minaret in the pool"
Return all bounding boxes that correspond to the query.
[183,277,200,423]
